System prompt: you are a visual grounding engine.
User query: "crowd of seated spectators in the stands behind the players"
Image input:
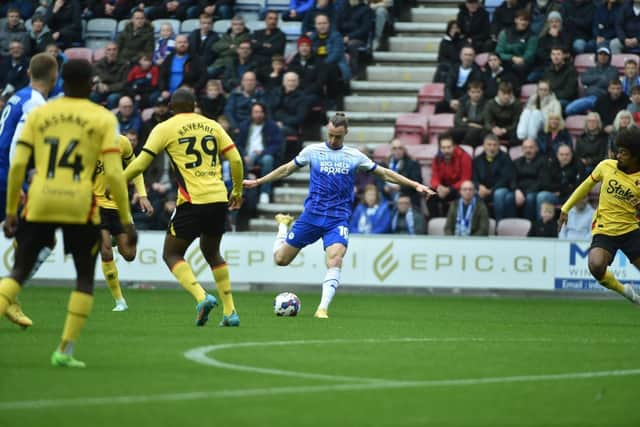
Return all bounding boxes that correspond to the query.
[0,0,640,241]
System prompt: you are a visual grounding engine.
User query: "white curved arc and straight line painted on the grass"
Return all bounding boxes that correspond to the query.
[0,338,640,411]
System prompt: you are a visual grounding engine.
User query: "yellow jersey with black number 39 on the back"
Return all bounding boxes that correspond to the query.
[142,113,234,205]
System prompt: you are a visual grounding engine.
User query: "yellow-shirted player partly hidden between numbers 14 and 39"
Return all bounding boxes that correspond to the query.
[93,135,153,311]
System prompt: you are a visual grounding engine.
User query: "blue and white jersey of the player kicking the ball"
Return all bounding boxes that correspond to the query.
[294,143,377,220]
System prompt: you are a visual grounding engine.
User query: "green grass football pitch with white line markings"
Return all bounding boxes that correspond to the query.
[0,288,640,427]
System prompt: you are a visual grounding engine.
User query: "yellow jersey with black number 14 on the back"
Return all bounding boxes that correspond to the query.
[18,97,120,224]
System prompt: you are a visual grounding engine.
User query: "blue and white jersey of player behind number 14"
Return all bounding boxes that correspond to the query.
[0,86,46,188]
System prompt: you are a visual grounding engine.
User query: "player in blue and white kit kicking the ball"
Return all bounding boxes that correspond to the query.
[244,113,435,319]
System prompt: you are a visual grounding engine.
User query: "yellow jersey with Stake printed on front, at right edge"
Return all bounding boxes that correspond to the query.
[587,160,640,236]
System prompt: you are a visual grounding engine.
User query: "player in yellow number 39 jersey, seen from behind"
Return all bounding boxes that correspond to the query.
[125,89,244,326]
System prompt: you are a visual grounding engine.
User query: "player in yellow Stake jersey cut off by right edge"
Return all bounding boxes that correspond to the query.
[558,128,640,304]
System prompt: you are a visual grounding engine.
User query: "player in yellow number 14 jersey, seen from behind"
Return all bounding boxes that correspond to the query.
[0,57,136,367]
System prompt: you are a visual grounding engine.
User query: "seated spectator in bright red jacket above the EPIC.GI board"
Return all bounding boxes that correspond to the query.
[427,132,472,217]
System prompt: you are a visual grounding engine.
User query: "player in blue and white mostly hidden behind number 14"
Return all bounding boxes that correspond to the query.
[0,53,58,328]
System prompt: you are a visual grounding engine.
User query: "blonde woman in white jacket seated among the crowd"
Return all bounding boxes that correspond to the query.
[516,80,562,140]
